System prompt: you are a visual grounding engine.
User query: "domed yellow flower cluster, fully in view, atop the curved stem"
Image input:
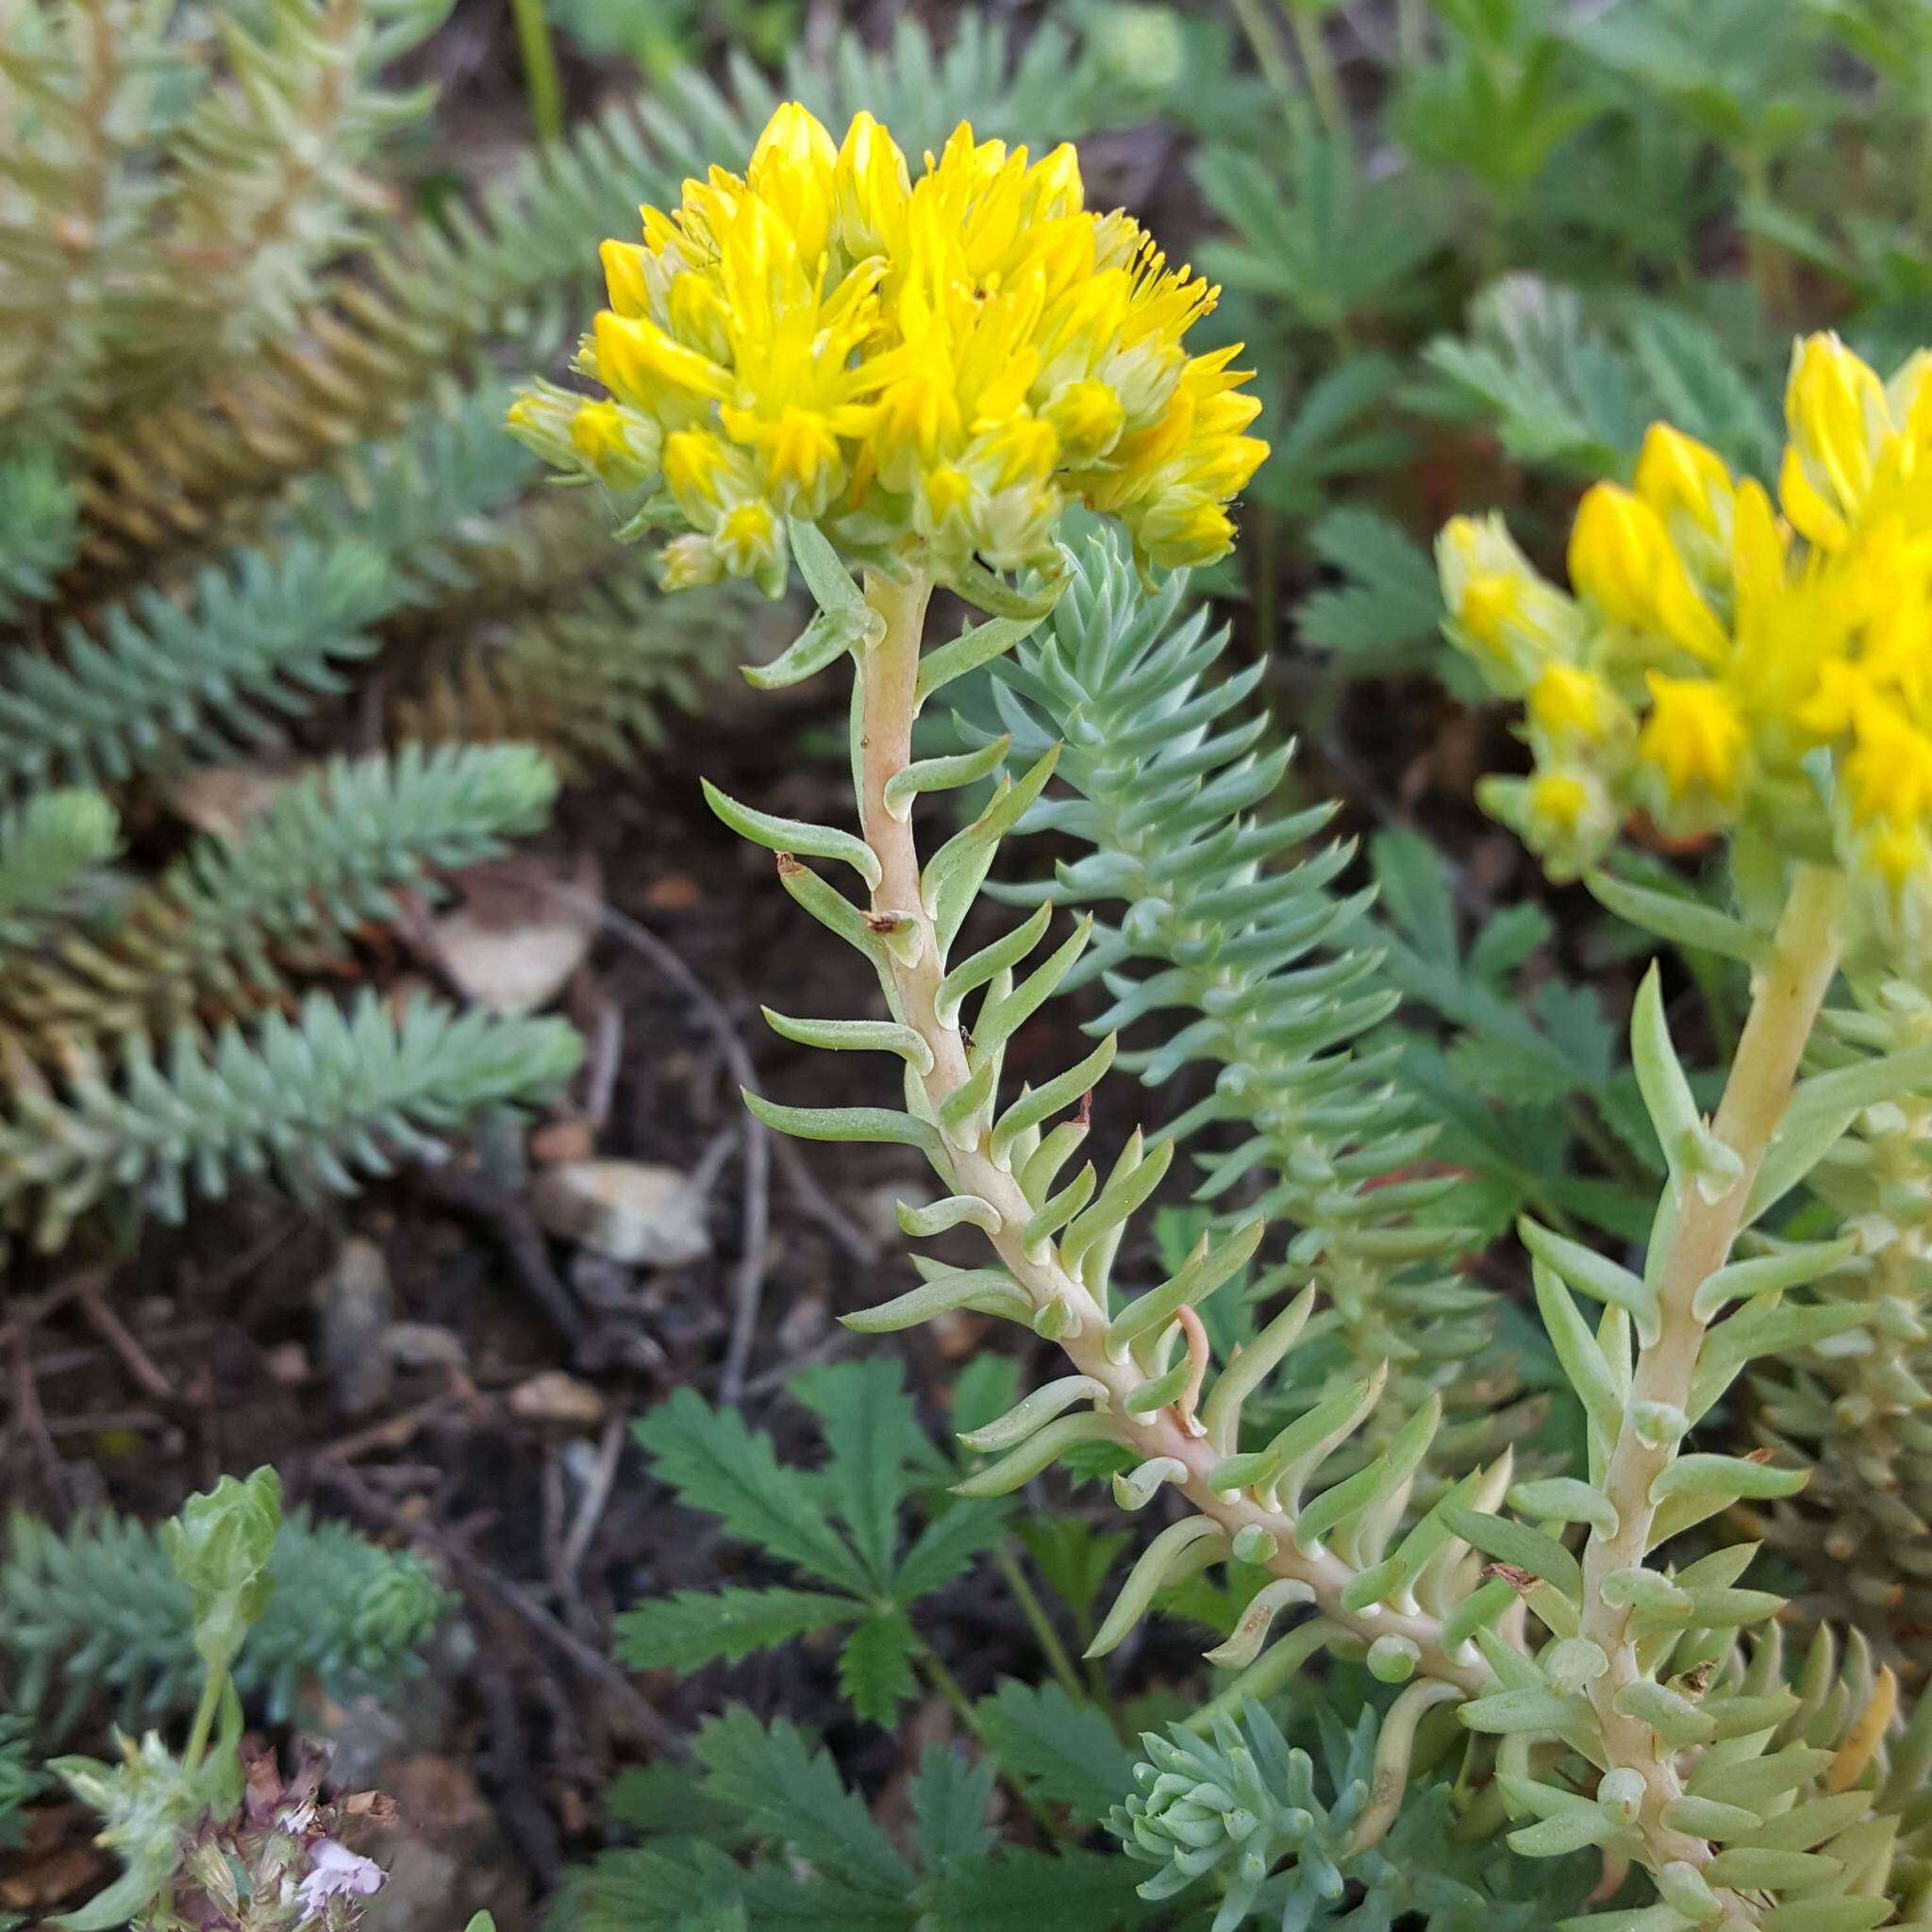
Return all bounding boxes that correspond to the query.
[510,105,1267,590]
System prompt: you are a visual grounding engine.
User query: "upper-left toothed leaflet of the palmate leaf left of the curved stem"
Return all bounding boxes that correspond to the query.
[636,1390,870,1596]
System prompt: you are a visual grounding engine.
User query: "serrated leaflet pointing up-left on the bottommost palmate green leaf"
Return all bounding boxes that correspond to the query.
[691,1707,912,1901]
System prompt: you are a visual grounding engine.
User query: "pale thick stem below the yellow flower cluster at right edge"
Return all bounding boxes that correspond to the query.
[1582,868,1845,1885]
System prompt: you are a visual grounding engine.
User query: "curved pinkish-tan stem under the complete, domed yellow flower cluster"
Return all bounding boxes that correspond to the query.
[858,574,1493,1696]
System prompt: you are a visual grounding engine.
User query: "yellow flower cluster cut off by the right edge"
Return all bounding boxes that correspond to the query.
[1438,336,1932,892]
